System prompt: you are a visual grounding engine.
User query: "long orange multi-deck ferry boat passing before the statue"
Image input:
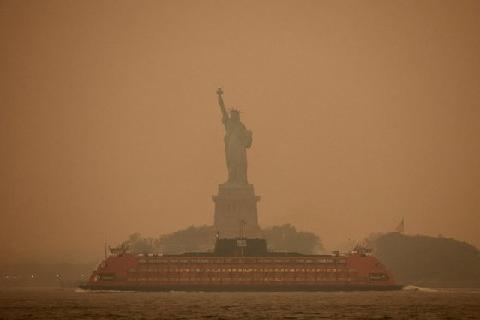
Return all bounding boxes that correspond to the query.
[80,238,401,291]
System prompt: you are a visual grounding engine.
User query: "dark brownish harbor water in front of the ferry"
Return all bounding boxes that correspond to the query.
[0,286,480,319]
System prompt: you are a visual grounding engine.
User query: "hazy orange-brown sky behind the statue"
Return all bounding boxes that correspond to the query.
[0,0,480,262]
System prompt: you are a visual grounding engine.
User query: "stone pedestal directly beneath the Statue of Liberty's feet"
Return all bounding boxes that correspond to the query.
[213,182,261,238]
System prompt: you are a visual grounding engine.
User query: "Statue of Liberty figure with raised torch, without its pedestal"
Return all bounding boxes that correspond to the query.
[217,88,252,184]
